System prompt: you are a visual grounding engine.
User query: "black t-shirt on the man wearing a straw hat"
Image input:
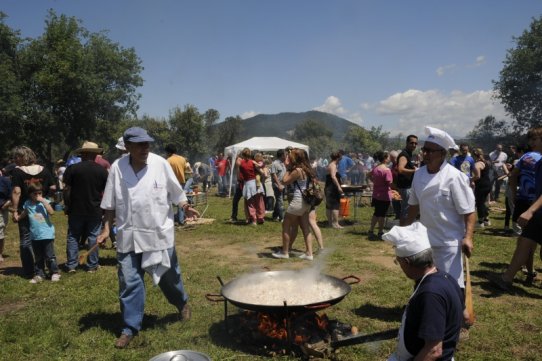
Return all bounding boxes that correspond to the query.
[62,160,108,216]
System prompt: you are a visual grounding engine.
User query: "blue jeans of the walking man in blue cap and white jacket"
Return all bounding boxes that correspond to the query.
[117,247,188,335]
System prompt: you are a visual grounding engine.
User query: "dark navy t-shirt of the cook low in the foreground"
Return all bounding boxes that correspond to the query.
[404,271,463,360]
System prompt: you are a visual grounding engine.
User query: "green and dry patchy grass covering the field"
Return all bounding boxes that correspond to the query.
[0,196,542,361]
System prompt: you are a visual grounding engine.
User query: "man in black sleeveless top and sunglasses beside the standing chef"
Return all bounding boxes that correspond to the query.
[397,134,418,219]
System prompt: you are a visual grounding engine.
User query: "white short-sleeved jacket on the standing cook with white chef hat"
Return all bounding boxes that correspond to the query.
[408,162,475,247]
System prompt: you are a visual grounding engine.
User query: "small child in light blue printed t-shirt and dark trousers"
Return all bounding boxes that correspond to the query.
[18,182,60,283]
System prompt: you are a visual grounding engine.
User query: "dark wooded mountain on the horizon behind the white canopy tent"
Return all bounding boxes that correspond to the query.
[236,110,359,141]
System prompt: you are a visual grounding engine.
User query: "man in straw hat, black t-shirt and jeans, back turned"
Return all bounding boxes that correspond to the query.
[63,142,108,273]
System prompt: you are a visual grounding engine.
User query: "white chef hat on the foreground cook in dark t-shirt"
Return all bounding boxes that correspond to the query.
[382,222,431,257]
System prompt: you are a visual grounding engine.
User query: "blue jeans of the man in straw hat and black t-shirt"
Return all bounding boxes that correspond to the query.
[66,216,102,270]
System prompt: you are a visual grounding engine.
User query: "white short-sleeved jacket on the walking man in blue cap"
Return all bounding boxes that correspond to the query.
[100,153,187,253]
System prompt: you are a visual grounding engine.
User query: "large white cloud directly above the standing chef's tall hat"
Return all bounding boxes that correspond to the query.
[376,89,509,136]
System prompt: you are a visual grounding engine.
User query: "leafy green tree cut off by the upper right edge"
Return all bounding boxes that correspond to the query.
[493,17,542,131]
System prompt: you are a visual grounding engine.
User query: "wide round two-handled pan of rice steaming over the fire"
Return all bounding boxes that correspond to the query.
[212,271,360,313]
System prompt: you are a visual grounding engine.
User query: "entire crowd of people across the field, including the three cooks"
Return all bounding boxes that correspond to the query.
[0,127,542,360]
